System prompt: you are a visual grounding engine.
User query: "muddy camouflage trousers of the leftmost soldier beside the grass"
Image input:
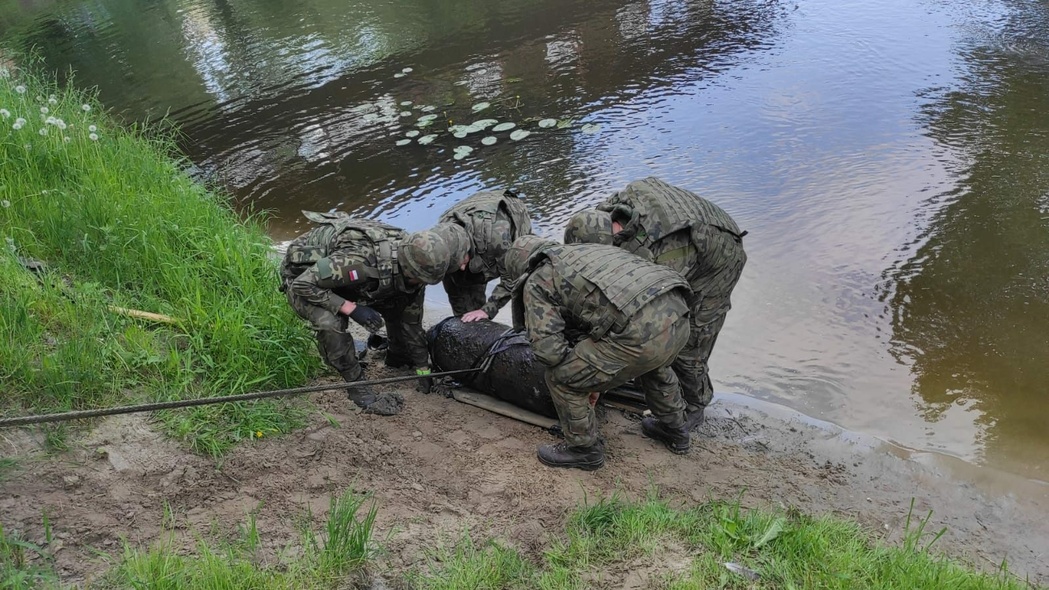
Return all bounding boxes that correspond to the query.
[284,289,429,381]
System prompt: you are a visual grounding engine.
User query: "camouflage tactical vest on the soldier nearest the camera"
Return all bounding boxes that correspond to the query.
[533,244,690,338]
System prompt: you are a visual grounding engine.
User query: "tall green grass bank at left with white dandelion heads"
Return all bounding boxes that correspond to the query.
[0,52,320,455]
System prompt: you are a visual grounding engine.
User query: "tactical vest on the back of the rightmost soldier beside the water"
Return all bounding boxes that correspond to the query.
[602,176,746,240]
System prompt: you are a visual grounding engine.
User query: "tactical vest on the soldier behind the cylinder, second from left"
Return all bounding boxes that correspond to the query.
[437,190,532,258]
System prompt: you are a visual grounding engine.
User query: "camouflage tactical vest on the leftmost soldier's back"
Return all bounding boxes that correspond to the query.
[281,211,406,289]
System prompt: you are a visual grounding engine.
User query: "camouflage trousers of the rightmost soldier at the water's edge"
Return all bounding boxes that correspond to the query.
[672,228,747,412]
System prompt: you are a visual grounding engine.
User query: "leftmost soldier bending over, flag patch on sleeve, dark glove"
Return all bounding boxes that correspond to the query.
[280,212,469,415]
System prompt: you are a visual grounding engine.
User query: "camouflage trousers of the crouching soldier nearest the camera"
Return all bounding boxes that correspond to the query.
[545,293,689,447]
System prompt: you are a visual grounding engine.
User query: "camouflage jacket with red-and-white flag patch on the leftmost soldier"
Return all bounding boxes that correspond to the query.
[280,212,421,314]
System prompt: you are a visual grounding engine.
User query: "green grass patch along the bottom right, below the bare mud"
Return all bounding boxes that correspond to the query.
[410,497,1031,590]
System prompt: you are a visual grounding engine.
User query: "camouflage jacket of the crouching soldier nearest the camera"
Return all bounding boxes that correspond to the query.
[514,244,689,366]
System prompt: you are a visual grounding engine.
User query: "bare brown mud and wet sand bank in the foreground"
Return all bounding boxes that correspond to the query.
[0,367,1049,587]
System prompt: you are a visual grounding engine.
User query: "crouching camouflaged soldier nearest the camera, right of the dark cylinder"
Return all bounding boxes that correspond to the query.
[506,235,689,470]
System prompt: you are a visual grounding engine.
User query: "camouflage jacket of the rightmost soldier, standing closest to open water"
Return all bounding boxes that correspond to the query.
[597,177,747,285]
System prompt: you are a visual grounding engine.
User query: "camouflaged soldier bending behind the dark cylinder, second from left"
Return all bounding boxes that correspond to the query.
[437,190,532,321]
